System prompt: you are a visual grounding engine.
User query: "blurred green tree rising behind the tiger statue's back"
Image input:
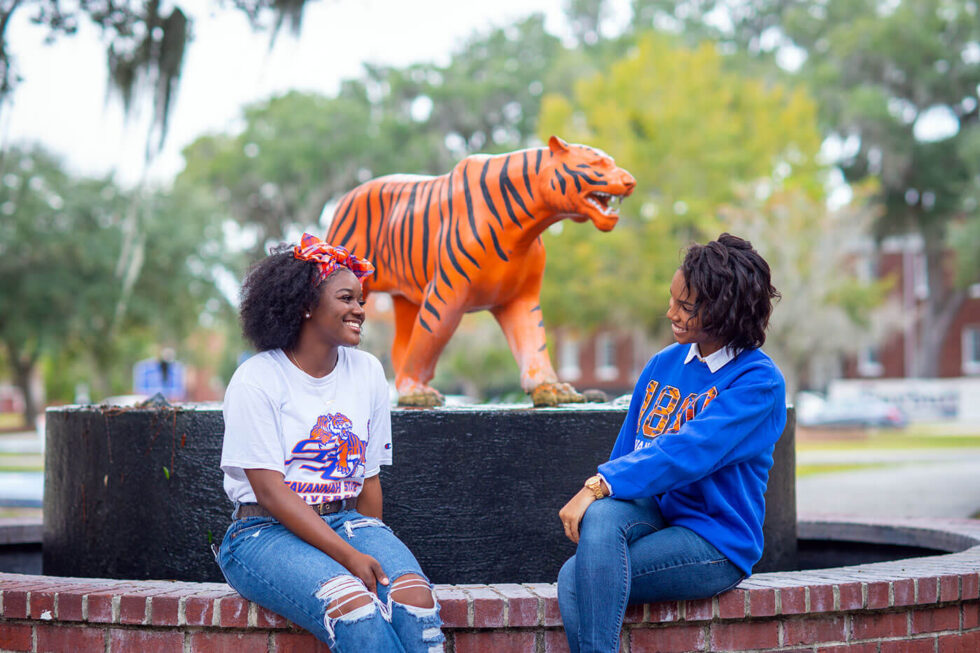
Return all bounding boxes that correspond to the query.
[181,15,573,260]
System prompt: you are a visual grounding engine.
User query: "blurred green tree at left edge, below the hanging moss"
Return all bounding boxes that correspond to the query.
[0,149,227,426]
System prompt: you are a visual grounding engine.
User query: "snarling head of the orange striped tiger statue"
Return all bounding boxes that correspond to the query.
[539,136,636,231]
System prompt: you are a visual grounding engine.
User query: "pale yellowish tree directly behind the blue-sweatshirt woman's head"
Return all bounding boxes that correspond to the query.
[721,186,900,398]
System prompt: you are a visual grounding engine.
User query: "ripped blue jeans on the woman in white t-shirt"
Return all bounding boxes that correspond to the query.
[218,510,444,653]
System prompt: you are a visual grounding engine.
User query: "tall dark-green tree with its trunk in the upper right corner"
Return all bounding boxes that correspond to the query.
[637,0,980,376]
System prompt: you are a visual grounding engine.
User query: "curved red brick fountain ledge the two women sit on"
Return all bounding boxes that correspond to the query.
[0,515,980,653]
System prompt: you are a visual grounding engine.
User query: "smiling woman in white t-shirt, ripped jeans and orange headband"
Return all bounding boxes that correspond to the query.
[218,234,444,653]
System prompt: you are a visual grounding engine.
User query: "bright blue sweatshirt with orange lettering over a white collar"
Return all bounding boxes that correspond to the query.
[599,344,786,575]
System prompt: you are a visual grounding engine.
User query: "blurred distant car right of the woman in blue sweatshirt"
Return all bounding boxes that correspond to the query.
[796,392,908,428]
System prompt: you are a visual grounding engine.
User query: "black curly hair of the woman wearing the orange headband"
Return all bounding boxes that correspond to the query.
[239,245,322,351]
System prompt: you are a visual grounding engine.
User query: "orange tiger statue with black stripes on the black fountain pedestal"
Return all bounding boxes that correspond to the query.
[326,136,636,406]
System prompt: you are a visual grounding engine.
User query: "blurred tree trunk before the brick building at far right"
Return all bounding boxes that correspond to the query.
[915,236,967,378]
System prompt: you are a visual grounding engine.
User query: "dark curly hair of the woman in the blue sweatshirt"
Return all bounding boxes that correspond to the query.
[680,233,780,352]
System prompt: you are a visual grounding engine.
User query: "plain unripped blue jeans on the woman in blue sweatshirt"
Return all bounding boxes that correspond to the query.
[558,498,745,653]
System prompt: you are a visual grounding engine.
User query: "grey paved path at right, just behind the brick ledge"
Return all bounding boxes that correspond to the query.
[796,448,980,517]
